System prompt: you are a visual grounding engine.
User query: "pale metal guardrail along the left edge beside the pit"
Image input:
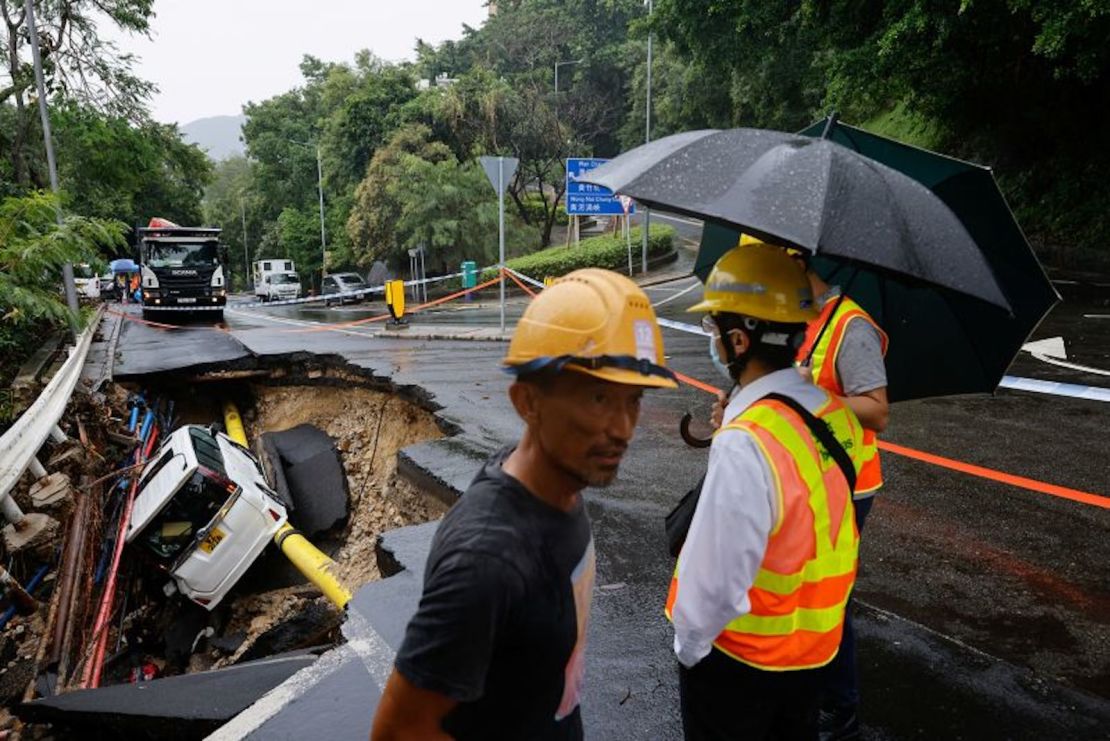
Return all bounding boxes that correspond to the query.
[0,307,103,522]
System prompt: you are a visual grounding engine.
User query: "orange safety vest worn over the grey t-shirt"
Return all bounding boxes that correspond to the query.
[797,296,888,499]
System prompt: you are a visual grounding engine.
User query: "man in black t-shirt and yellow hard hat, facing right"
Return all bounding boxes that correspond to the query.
[372,268,675,741]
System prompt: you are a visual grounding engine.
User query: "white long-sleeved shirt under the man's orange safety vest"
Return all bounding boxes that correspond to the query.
[672,368,828,667]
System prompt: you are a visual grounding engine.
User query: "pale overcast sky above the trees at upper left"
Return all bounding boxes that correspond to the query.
[104,0,487,124]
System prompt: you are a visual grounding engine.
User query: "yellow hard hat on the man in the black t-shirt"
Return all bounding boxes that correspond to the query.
[502,267,677,388]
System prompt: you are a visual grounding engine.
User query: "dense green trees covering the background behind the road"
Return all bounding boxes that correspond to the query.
[0,0,1110,381]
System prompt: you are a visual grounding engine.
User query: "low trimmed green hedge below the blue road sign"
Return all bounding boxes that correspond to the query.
[482,225,675,281]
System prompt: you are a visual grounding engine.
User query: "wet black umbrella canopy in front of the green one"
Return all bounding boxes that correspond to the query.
[586,129,1009,309]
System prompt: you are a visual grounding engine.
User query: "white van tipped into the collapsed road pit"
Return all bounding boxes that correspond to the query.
[127,425,286,610]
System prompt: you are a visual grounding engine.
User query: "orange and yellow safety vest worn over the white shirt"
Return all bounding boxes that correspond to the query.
[666,395,862,671]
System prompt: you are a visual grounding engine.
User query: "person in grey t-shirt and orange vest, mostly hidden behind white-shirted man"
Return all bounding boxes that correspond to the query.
[796,254,890,741]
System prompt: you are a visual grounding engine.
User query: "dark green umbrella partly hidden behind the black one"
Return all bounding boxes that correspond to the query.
[695,119,1059,402]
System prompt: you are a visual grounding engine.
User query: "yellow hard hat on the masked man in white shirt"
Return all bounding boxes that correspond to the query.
[688,235,817,324]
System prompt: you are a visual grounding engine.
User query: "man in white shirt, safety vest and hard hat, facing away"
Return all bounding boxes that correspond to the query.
[666,243,862,741]
